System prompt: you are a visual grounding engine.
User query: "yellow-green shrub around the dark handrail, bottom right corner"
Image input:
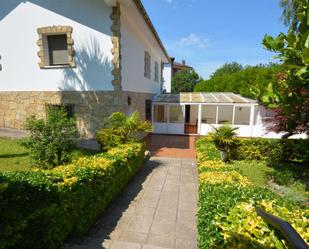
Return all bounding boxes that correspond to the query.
[216,201,309,248]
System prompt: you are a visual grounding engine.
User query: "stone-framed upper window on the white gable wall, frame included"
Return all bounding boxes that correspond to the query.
[37,26,75,68]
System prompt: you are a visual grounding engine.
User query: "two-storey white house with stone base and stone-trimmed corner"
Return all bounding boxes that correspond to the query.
[0,0,170,137]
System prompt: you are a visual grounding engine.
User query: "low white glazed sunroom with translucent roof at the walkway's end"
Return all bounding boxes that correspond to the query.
[152,92,306,138]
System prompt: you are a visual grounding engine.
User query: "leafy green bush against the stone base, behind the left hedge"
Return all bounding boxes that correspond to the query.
[22,107,78,169]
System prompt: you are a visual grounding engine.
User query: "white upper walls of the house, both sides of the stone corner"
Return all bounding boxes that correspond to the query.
[0,0,168,94]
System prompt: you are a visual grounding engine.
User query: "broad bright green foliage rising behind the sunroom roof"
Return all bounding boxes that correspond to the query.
[194,62,280,100]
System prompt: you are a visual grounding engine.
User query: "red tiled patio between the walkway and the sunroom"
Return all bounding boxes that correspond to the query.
[145,134,196,158]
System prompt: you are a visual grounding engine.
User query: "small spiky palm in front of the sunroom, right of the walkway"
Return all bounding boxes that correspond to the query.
[210,125,238,162]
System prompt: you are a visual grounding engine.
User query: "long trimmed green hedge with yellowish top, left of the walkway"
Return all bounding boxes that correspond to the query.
[0,143,145,249]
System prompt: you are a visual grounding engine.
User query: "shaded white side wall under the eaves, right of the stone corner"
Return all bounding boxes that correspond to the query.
[121,1,167,94]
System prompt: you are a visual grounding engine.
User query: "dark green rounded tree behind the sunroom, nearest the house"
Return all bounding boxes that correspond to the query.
[172,69,201,93]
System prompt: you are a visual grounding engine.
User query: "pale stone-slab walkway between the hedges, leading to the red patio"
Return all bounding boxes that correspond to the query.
[63,157,197,249]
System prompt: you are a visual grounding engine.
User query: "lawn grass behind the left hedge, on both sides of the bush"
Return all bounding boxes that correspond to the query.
[0,137,98,171]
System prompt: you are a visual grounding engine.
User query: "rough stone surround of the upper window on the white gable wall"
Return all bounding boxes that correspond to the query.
[37,25,76,69]
